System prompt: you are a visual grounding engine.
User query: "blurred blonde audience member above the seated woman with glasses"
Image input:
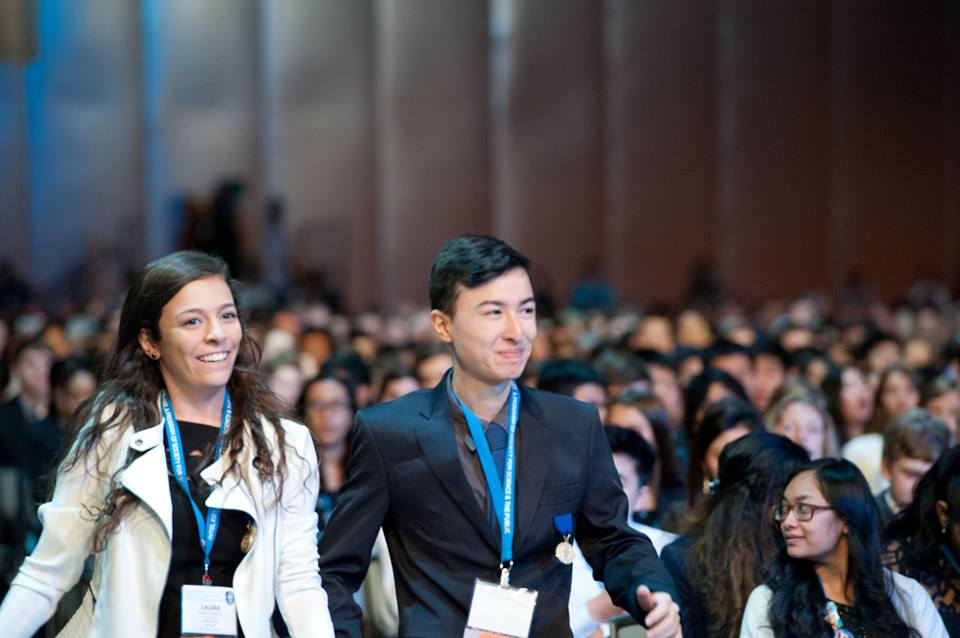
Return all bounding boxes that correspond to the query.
[765,388,839,461]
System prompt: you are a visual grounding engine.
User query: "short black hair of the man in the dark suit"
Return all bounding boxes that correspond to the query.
[427,235,530,314]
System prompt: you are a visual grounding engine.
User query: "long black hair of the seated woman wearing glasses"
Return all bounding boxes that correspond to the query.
[767,458,919,638]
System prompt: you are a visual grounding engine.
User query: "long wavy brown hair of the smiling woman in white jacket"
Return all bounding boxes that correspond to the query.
[58,251,286,551]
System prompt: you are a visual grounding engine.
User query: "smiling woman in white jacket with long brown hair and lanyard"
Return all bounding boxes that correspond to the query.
[0,252,333,637]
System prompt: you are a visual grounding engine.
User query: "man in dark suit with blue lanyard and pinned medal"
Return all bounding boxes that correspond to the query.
[320,235,680,638]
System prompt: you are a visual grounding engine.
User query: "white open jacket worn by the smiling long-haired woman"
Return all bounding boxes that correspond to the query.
[0,412,333,638]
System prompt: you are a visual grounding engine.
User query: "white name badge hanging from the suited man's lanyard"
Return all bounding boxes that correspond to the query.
[463,578,537,638]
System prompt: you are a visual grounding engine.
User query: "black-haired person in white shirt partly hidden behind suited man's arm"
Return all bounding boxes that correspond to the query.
[569,425,676,638]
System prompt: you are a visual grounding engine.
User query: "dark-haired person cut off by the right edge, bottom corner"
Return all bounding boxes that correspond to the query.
[883,446,960,636]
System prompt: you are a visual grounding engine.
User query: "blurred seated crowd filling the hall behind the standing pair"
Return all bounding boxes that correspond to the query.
[0,264,960,635]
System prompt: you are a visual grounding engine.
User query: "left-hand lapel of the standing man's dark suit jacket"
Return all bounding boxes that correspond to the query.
[417,382,500,551]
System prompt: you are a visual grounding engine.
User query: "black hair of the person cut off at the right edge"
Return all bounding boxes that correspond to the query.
[887,445,960,573]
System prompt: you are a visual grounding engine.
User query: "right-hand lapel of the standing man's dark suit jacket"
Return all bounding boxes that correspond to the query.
[513,386,551,554]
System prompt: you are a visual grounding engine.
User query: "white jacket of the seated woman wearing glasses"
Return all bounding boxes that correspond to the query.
[740,569,949,638]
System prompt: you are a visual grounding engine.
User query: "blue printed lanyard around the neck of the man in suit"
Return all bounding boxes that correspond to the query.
[450,383,520,584]
